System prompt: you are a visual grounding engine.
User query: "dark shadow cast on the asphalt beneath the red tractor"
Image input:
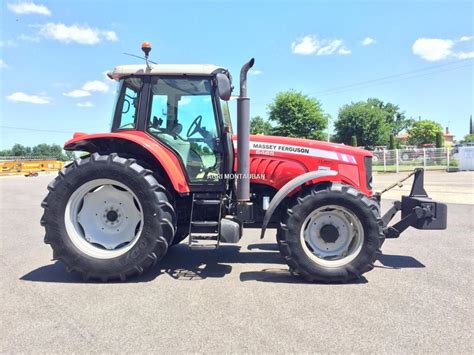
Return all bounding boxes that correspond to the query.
[20,243,425,284]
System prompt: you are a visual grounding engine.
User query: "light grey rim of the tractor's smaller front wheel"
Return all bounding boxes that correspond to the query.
[301,205,364,267]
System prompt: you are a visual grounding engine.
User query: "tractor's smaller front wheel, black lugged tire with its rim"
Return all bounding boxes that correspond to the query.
[277,184,383,282]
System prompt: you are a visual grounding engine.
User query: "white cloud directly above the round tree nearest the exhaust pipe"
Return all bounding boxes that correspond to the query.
[291,35,351,55]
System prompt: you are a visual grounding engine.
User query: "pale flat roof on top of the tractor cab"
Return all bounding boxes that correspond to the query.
[107,64,227,80]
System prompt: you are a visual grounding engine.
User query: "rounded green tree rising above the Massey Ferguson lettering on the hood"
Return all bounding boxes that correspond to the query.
[268,90,329,139]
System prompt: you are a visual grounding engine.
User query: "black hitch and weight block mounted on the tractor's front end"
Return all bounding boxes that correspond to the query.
[376,169,447,238]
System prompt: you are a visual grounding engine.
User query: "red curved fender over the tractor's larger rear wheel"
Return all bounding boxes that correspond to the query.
[64,131,190,194]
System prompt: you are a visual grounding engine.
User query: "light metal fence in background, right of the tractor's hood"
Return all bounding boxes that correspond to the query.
[372,147,459,173]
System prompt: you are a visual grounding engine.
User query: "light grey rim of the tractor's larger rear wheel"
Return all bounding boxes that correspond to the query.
[64,179,144,259]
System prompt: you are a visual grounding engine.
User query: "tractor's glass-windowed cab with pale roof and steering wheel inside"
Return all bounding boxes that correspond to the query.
[109,64,233,190]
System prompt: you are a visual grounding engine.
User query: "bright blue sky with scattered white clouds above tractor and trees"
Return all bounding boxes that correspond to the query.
[0,0,474,149]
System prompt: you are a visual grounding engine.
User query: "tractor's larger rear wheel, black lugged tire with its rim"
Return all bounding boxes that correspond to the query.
[41,153,176,282]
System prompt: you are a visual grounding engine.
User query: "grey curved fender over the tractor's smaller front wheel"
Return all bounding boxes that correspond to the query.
[260,170,337,239]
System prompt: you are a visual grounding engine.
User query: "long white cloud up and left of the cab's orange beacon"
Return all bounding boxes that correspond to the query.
[39,22,118,45]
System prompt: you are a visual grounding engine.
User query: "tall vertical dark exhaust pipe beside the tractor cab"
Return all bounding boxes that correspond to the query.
[236,58,255,202]
